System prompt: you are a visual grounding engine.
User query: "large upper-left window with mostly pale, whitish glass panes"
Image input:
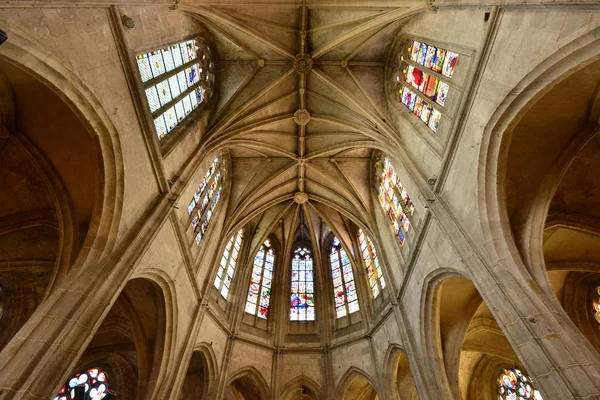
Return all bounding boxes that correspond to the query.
[136,38,215,139]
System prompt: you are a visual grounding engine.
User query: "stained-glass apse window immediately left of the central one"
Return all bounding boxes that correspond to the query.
[246,239,275,319]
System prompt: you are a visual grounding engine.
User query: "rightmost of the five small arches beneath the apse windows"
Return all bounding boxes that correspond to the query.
[382,344,418,400]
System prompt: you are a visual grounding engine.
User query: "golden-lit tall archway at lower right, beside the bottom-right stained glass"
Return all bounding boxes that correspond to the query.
[425,271,540,400]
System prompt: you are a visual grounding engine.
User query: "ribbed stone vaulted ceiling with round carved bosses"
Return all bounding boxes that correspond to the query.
[183,1,426,244]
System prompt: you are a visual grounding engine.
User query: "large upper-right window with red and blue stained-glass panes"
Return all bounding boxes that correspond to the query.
[395,40,459,132]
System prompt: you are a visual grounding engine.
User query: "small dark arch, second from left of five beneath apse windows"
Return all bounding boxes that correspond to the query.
[224,366,271,400]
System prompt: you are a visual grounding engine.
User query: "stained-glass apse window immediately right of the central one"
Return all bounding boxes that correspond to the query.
[329,238,358,318]
